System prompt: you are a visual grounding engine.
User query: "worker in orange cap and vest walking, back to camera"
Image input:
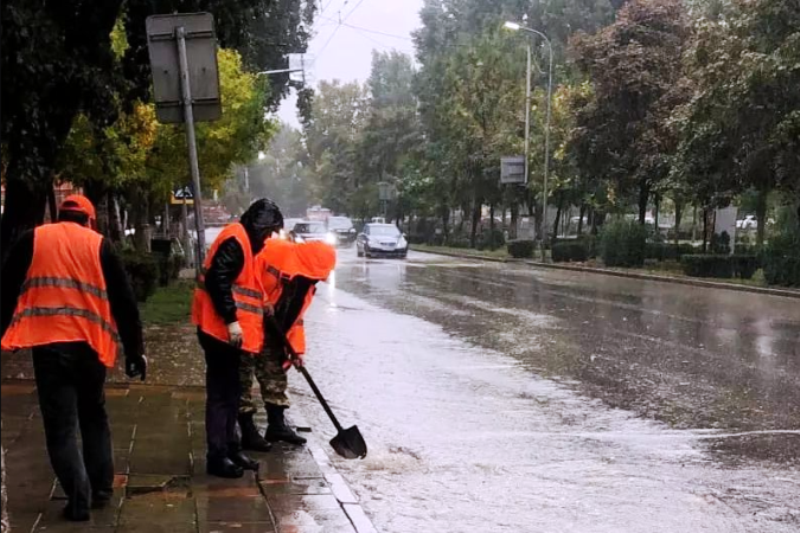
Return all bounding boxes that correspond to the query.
[2,195,147,521]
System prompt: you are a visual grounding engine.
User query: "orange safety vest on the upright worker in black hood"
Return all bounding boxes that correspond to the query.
[192,223,264,354]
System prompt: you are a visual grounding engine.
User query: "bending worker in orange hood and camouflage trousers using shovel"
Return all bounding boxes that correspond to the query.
[239,239,336,451]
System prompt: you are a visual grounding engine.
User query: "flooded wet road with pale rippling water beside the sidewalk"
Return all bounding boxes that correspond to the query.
[292,251,800,533]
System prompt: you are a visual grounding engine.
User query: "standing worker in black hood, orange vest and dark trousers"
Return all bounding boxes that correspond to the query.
[192,198,283,478]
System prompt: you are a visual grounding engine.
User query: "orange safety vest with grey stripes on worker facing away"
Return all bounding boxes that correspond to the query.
[2,222,120,368]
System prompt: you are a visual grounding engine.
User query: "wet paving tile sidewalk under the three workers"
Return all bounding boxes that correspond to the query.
[2,380,374,533]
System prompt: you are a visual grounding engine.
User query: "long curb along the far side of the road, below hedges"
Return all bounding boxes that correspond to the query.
[412,248,800,299]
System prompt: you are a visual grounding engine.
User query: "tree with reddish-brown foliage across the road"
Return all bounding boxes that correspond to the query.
[573,0,688,224]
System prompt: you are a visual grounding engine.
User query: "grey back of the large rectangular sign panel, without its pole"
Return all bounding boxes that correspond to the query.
[146,13,222,123]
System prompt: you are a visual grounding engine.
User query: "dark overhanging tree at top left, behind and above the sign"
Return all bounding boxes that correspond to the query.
[0,0,316,254]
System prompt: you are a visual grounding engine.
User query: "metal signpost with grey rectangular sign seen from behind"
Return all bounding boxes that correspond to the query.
[147,13,222,272]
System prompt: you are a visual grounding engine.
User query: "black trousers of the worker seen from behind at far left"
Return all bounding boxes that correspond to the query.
[33,343,114,511]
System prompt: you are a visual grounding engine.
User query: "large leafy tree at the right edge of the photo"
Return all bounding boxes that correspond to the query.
[673,0,800,246]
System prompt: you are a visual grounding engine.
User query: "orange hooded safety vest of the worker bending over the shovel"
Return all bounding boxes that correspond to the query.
[256,239,336,354]
